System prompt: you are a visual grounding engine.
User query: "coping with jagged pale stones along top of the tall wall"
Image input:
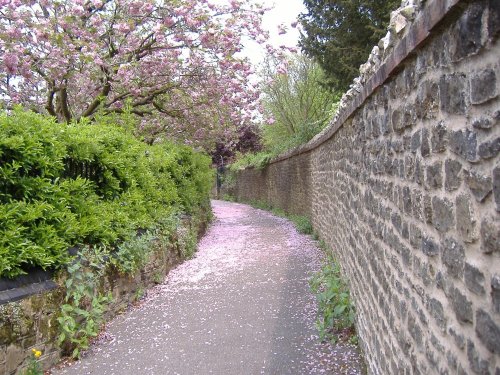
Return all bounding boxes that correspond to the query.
[270,0,466,164]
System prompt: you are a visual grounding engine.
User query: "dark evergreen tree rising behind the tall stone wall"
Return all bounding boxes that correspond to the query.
[299,0,401,91]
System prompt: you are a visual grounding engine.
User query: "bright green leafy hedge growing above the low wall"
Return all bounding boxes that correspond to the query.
[0,109,213,277]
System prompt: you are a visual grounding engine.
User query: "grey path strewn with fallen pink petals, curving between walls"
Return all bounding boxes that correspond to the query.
[53,201,361,375]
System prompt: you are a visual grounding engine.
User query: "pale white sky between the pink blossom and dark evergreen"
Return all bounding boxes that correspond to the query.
[243,0,305,65]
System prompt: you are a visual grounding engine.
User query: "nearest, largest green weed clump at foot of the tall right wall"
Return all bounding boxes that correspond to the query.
[309,251,355,342]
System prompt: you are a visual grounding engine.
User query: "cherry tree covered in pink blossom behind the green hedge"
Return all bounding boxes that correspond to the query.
[0,0,272,147]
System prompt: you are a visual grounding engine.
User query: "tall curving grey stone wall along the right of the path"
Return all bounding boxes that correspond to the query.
[234,0,500,375]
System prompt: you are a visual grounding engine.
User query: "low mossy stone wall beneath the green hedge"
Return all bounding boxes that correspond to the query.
[0,210,210,375]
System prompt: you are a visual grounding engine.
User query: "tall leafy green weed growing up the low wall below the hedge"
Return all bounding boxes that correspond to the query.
[57,247,111,358]
